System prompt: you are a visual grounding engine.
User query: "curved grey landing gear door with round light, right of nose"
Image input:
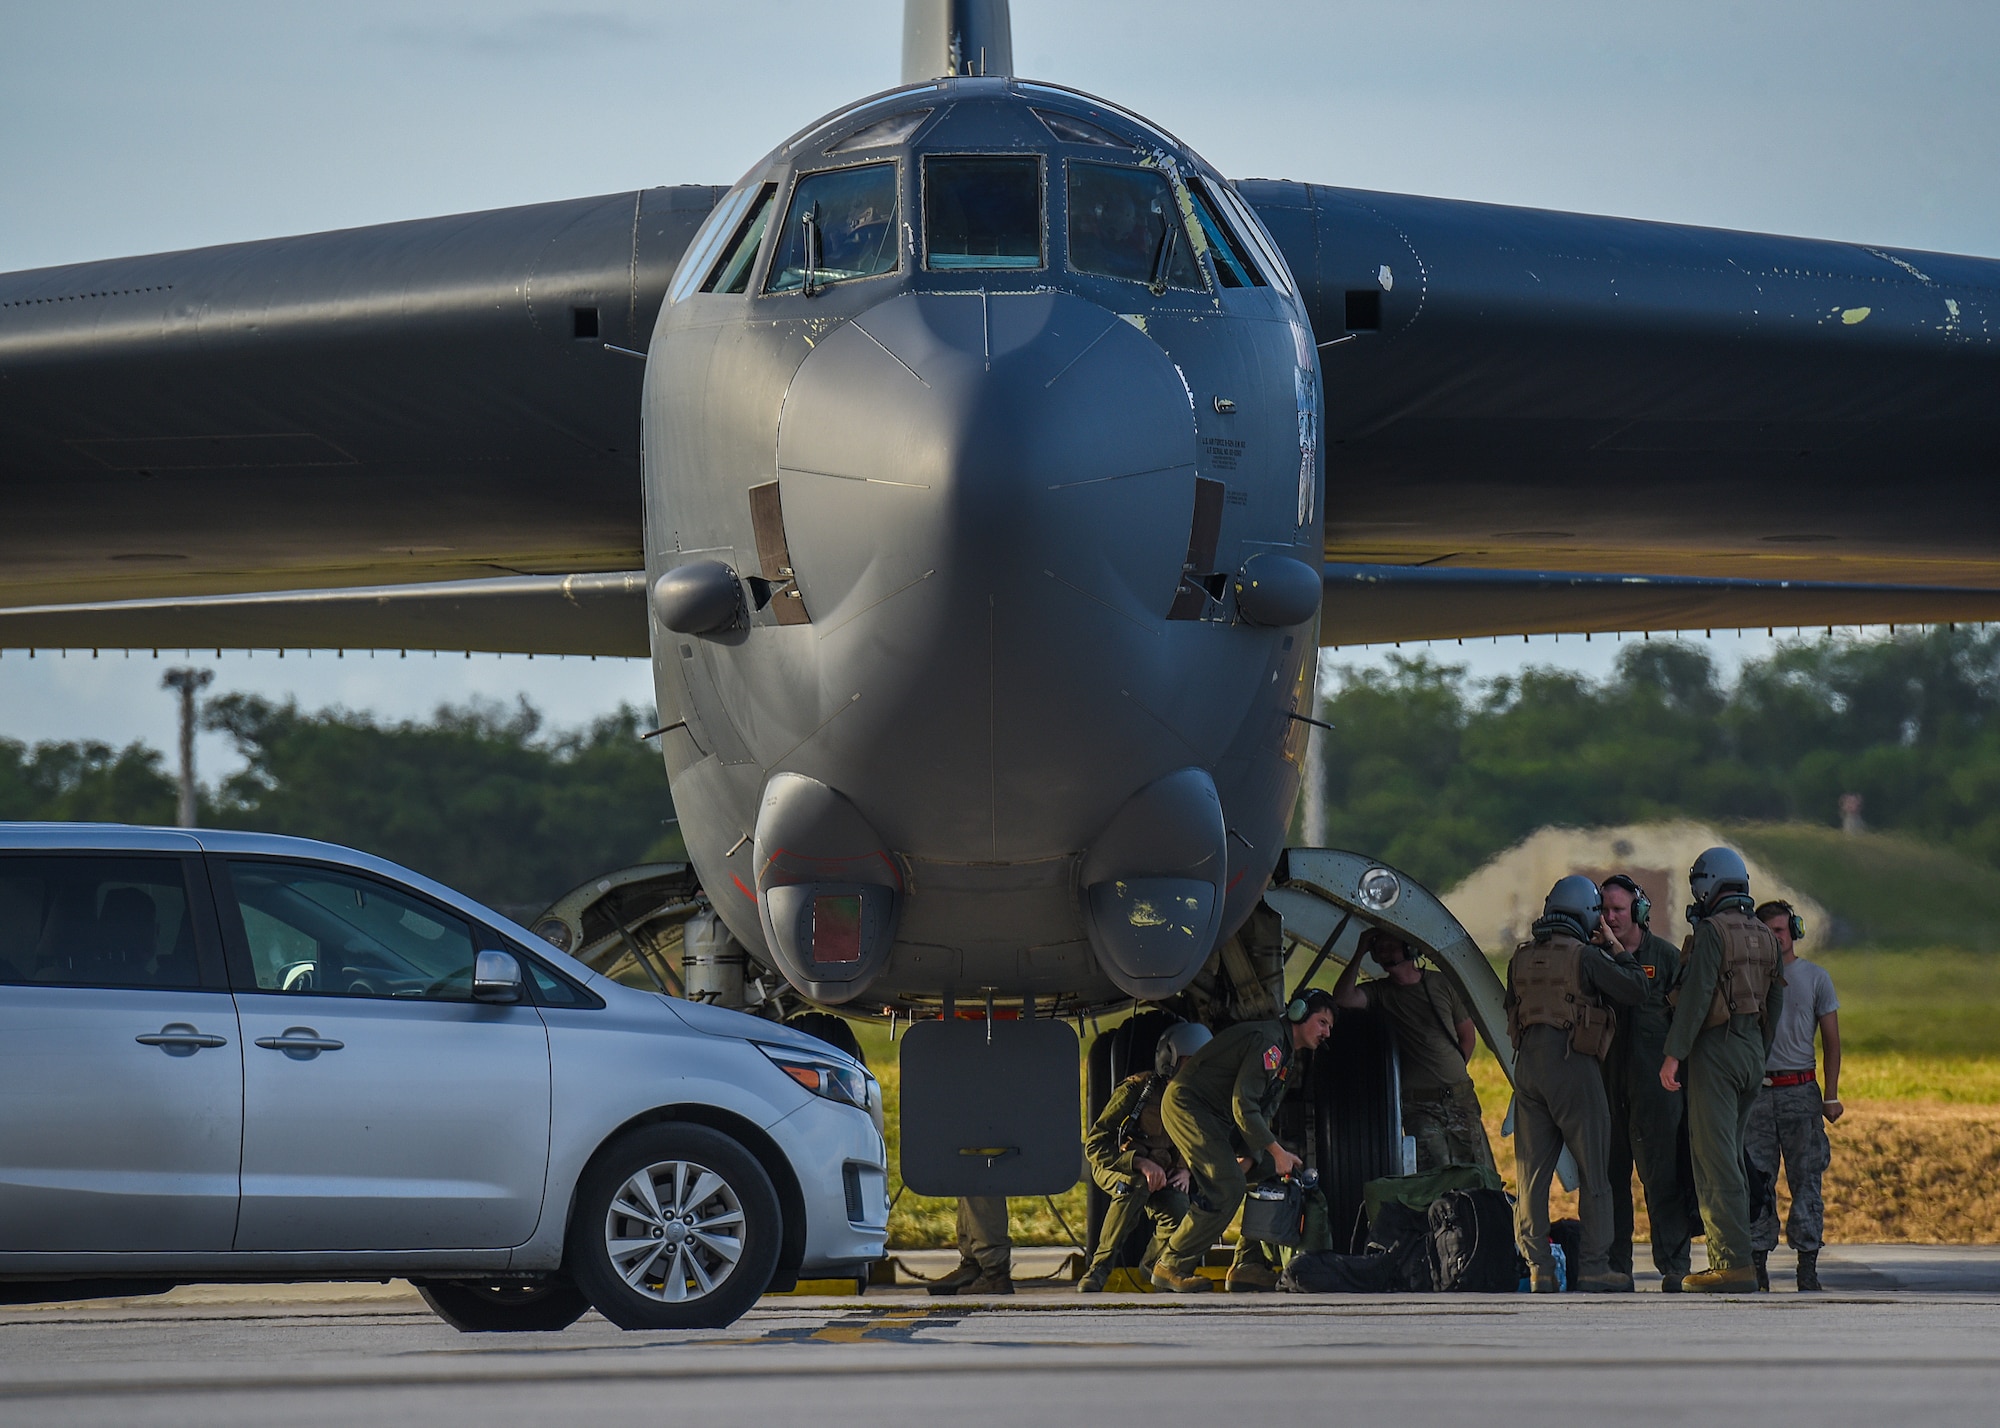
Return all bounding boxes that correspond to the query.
[1264,848,1514,1082]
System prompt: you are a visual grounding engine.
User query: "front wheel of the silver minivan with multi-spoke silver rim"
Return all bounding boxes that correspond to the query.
[564,1122,784,1328]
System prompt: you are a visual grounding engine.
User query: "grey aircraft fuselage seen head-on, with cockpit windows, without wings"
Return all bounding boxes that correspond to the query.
[644,78,1322,1008]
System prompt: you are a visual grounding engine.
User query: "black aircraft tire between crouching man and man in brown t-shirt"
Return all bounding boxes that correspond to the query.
[1310,1012,1402,1254]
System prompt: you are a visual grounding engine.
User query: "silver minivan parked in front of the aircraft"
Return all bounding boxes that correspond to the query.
[0,824,888,1330]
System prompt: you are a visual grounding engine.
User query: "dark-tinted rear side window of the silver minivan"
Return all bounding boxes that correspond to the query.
[0,856,202,990]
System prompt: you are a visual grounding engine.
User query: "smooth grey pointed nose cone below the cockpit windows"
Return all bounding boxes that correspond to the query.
[778,292,1196,860]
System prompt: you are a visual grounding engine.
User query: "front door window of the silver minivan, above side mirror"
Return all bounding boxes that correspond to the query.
[228,858,476,1002]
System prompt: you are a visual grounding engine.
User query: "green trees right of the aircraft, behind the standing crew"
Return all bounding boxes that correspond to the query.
[1322,628,2000,888]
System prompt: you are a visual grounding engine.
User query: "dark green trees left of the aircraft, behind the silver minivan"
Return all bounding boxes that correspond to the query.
[0,694,682,912]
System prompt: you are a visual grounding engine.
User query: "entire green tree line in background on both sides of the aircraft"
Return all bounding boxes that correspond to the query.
[15,630,2000,908]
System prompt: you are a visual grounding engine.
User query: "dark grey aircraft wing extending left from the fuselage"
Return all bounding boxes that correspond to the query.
[0,186,722,624]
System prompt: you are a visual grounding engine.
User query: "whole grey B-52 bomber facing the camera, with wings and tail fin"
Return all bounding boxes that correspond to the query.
[0,0,2000,1190]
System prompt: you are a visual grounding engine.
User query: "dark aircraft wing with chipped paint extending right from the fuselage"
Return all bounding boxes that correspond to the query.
[1238,180,2000,642]
